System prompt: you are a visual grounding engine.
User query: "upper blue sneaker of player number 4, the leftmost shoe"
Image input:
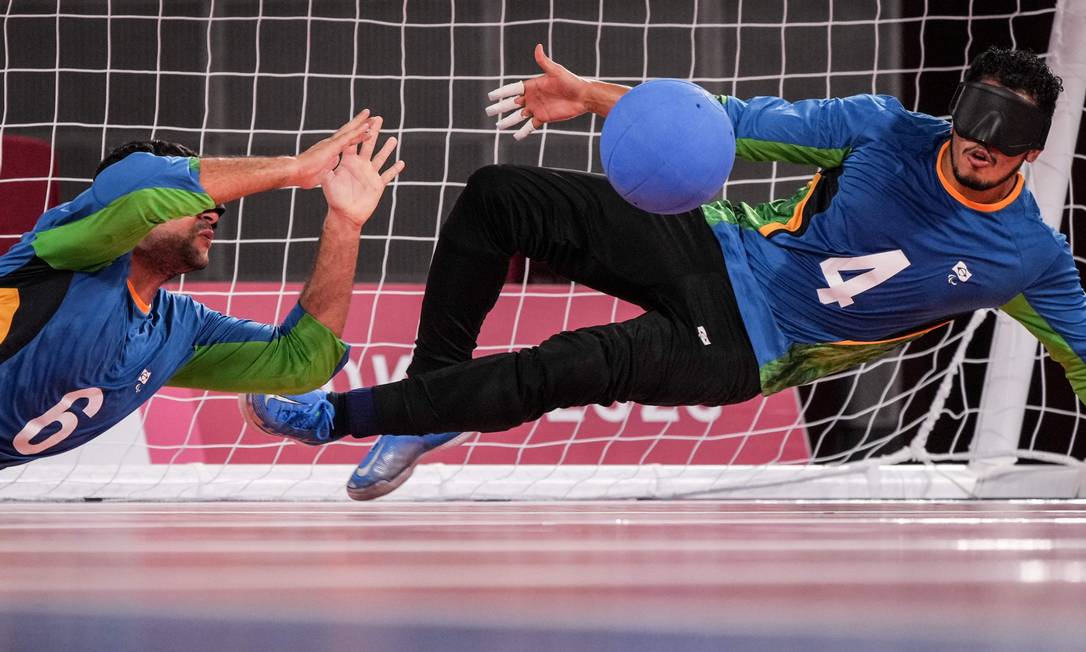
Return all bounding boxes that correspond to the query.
[238,389,339,446]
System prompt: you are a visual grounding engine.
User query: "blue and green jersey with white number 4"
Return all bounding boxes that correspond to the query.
[703,91,1086,401]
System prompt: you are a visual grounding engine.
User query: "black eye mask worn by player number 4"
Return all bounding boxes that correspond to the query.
[950,82,1052,156]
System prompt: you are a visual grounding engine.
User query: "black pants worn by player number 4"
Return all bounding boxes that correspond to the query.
[364,165,759,436]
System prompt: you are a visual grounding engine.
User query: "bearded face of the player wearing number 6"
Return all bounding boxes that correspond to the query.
[132,211,218,278]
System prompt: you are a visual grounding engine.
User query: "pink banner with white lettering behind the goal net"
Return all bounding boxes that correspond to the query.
[144,283,809,464]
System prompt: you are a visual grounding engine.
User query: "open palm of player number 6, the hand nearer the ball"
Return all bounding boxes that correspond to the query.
[320,117,404,227]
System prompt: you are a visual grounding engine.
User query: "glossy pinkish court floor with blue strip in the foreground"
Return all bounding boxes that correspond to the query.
[0,501,1086,652]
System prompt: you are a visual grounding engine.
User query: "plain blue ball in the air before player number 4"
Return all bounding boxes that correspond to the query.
[599,79,735,214]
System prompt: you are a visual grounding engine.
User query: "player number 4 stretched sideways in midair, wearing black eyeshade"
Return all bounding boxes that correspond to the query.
[245,46,1086,499]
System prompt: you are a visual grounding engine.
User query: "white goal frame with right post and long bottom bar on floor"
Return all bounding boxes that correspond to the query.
[0,0,1086,500]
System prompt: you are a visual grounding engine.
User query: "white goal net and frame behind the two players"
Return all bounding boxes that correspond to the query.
[0,0,1086,500]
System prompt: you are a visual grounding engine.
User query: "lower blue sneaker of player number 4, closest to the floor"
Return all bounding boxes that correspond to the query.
[346,432,470,500]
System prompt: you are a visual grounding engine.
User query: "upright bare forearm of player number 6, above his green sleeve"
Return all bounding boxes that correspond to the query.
[300,210,362,337]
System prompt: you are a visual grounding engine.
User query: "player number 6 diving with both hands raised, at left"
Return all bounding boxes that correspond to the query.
[0,110,404,468]
